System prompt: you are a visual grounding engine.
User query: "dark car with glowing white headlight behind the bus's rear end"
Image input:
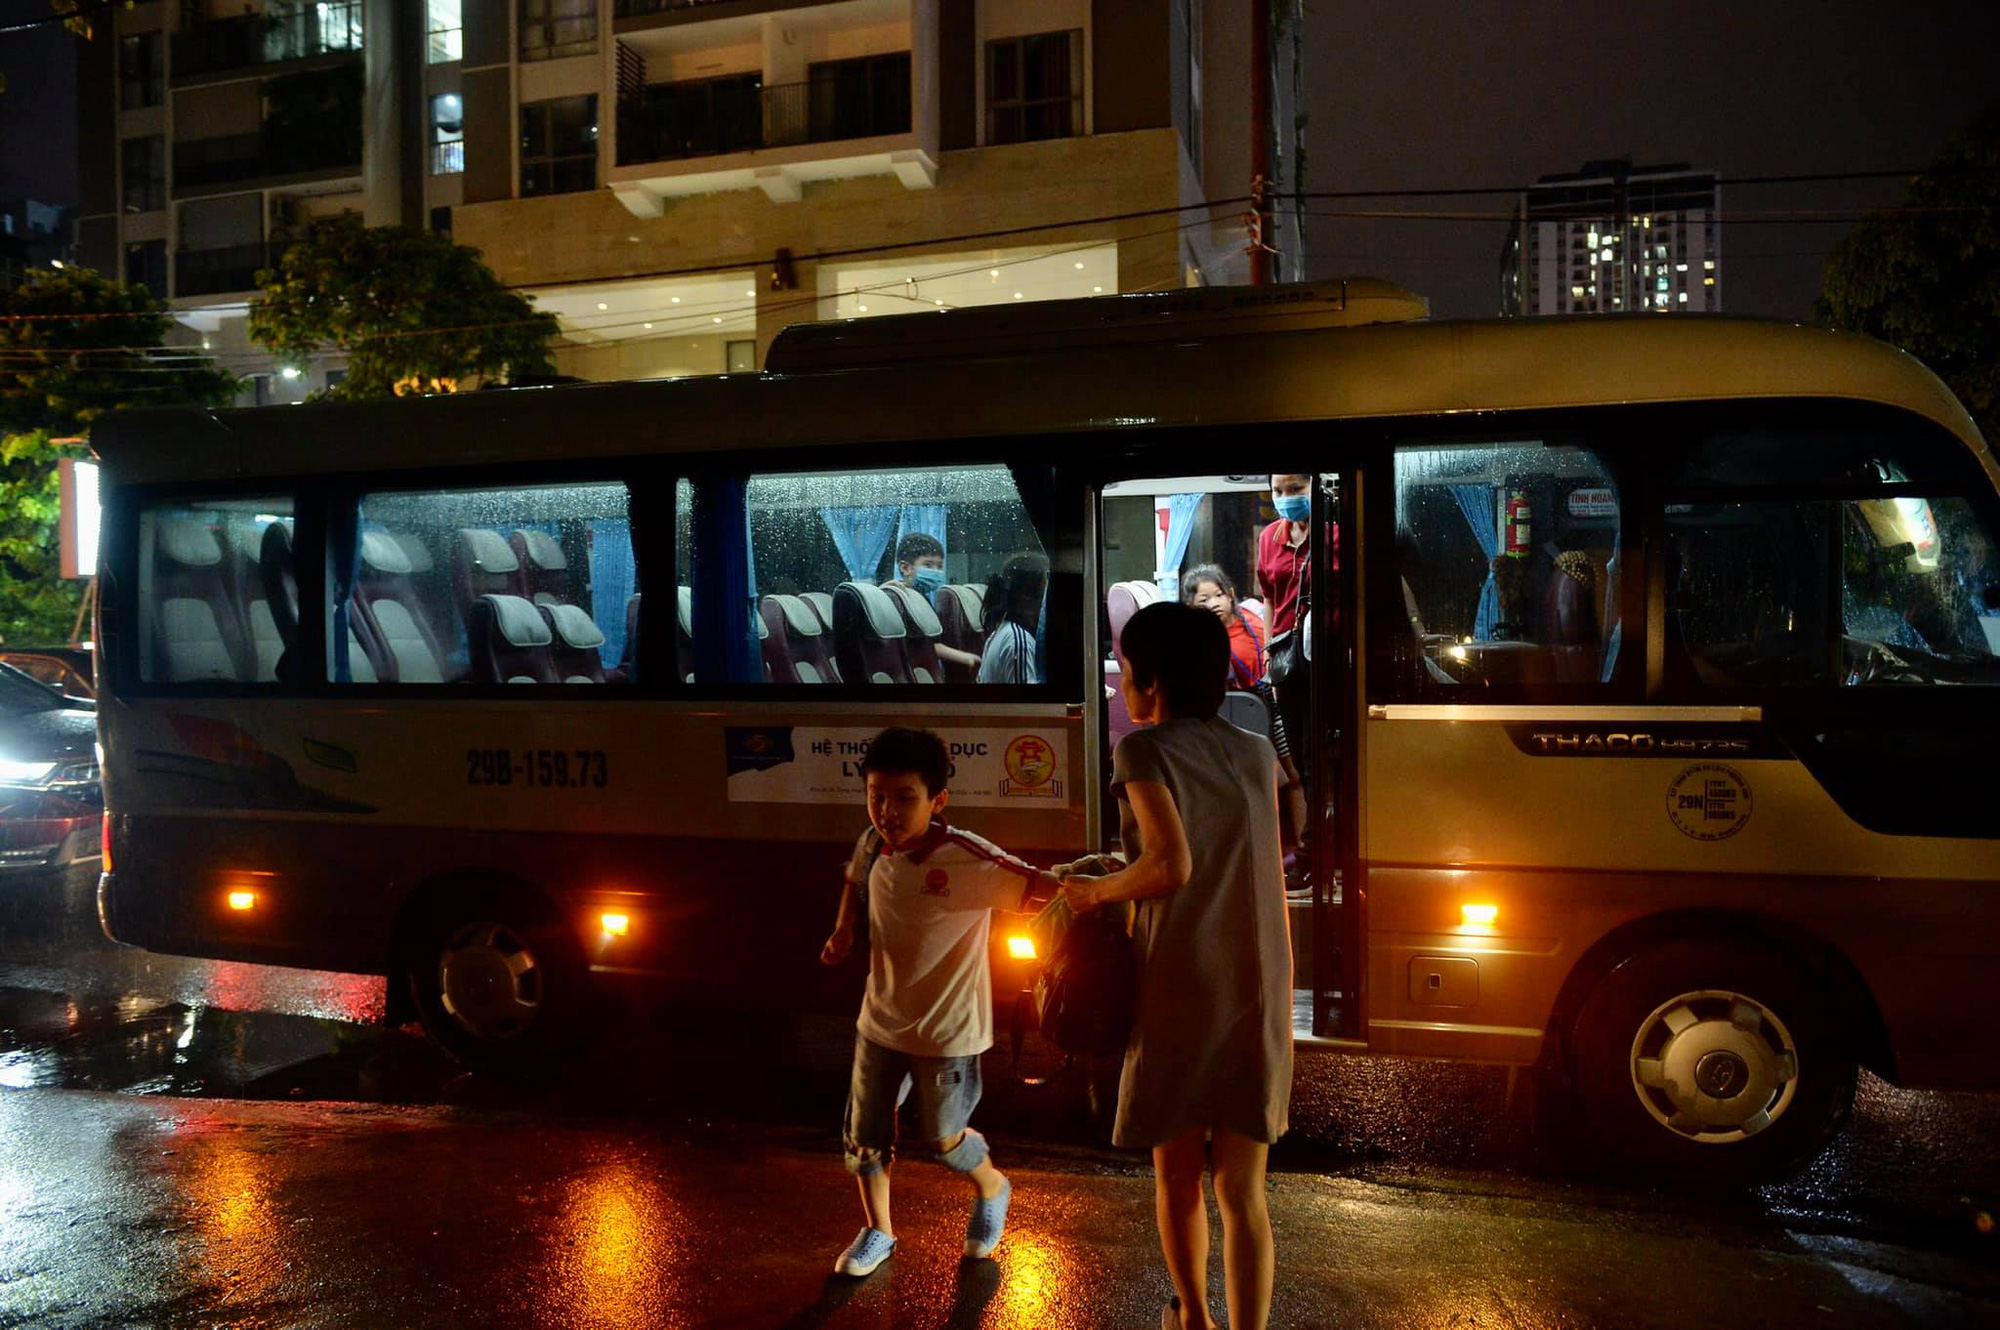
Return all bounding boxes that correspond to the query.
[0,664,104,872]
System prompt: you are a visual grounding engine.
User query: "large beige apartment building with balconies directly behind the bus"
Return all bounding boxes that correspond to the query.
[78,0,1302,400]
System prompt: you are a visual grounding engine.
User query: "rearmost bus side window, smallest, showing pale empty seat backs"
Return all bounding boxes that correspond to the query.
[138,494,298,684]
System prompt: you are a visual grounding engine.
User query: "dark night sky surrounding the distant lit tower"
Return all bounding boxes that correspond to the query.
[1306,0,2000,318]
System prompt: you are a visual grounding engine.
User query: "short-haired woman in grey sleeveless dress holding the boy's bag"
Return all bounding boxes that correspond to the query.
[1064,604,1292,1330]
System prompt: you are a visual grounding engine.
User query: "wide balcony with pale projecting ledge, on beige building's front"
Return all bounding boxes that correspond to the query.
[610,52,936,216]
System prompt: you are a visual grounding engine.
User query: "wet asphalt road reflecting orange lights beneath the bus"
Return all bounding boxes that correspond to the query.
[0,874,2000,1328]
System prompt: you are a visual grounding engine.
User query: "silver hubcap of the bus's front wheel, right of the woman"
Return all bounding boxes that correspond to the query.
[1632,988,1798,1144]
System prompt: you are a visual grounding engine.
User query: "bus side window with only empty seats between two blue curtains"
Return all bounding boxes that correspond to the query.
[326,482,638,684]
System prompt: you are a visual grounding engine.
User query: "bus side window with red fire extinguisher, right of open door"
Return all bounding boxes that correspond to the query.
[1396,440,1624,696]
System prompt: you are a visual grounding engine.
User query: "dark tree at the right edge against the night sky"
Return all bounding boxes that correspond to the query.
[1814,102,2000,442]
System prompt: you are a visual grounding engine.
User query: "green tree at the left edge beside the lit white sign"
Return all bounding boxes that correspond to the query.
[0,268,236,644]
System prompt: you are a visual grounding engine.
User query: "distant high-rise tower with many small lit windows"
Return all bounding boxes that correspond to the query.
[1500,158,1722,314]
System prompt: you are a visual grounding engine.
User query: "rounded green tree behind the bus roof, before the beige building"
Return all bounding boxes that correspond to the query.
[250,216,556,398]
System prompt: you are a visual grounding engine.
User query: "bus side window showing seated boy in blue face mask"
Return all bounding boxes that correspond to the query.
[676,464,1050,686]
